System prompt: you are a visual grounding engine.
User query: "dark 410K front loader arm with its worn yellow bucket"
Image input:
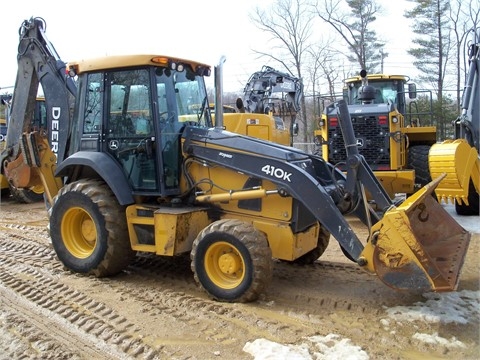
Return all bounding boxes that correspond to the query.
[183,100,470,291]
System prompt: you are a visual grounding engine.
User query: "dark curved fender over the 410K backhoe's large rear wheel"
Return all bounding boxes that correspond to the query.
[55,151,134,206]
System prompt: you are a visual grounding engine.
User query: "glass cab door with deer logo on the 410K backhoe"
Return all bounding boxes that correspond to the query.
[104,68,160,195]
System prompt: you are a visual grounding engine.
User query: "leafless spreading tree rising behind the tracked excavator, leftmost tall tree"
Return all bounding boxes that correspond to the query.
[250,0,313,142]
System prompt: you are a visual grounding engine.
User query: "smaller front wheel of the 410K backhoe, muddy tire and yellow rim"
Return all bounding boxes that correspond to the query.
[190,219,273,302]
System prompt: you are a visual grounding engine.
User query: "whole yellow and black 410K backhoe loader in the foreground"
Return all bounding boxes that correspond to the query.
[1,18,470,302]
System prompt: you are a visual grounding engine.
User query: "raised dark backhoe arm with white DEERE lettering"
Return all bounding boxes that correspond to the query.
[2,18,76,160]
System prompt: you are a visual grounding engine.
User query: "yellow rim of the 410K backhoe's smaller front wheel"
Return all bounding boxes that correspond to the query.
[205,241,245,289]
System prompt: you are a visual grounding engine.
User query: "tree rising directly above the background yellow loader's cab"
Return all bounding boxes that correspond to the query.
[315,0,387,72]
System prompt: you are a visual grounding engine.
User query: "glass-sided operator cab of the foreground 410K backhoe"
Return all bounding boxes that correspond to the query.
[71,56,212,197]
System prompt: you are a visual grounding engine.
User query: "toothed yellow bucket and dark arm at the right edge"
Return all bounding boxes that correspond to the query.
[428,28,480,215]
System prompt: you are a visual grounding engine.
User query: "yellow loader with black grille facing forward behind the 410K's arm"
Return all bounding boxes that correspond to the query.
[314,70,437,198]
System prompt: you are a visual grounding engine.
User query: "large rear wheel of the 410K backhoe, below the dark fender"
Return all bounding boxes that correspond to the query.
[50,180,135,277]
